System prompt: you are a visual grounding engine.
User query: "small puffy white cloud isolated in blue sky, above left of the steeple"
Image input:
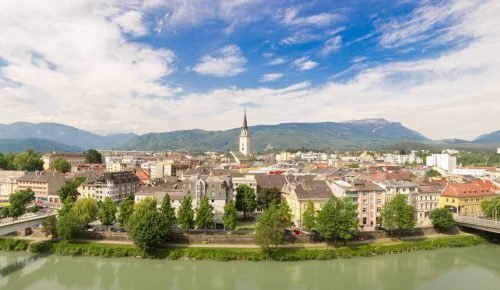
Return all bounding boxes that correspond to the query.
[193,45,247,77]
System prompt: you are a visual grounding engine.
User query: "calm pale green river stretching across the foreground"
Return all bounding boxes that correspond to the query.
[0,245,500,290]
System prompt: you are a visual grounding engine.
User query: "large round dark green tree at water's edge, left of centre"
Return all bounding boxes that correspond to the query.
[131,211,172,252]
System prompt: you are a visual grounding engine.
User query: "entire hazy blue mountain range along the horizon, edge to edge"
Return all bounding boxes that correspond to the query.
[0,119,500,152]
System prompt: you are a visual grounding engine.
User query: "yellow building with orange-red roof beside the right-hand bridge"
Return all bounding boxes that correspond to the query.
[439,180,496,216]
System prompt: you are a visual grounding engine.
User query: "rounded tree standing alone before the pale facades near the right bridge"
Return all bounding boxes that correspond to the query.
[382,194,416,237]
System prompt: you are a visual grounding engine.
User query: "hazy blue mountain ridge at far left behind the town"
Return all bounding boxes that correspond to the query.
[0,122,136,149]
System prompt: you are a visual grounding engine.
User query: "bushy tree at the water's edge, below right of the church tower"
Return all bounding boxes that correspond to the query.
[255,202,293,250]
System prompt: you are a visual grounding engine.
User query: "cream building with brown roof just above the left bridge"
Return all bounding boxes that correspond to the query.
[17,171,66,207]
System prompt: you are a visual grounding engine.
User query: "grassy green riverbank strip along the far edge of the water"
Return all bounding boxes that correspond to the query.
[0,235,486,261]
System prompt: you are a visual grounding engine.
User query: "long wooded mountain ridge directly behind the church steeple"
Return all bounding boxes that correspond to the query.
[125,119,429,151]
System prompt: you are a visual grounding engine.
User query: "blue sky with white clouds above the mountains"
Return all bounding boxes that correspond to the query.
[0,0,500,140]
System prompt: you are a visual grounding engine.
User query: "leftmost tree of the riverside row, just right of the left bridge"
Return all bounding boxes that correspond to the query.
[56,197,86,240]
